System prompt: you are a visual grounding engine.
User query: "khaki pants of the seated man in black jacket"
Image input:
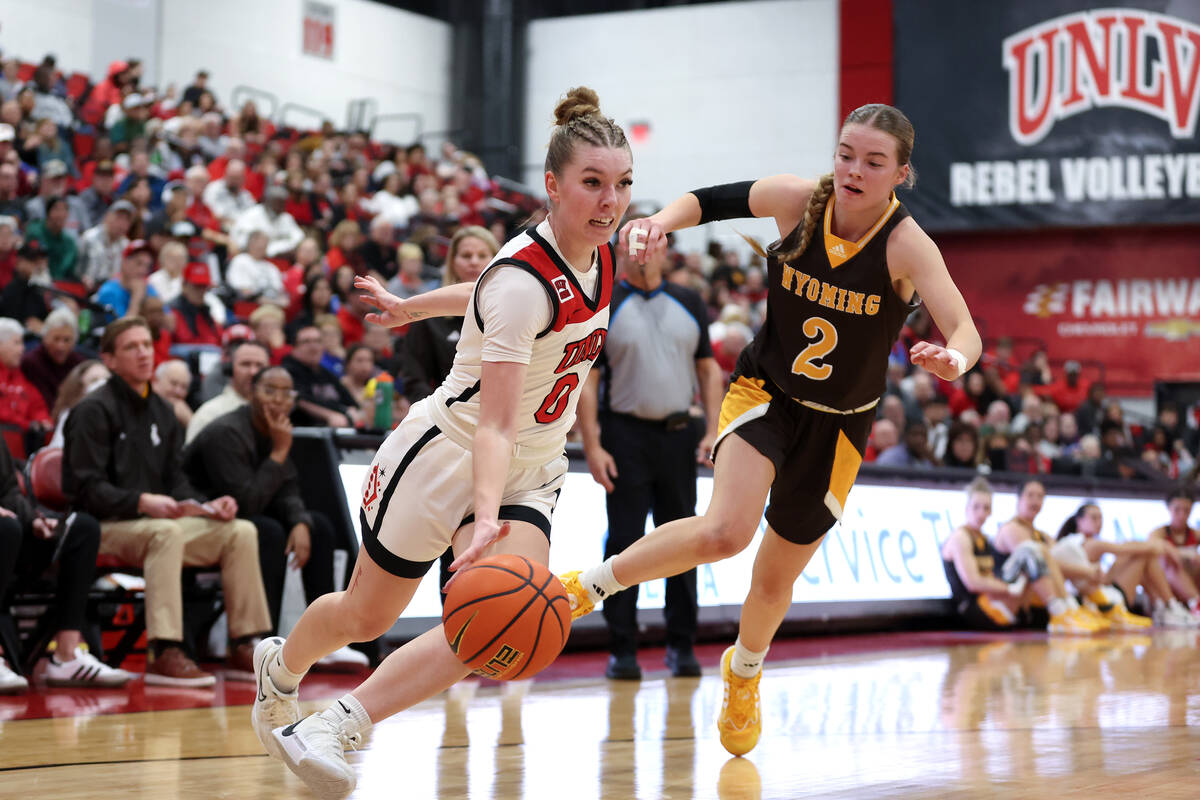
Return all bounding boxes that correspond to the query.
[100,517,271,642]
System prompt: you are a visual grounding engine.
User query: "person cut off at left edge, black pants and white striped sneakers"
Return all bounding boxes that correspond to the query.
[0,439,133,693]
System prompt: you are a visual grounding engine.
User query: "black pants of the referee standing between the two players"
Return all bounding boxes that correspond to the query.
[600,414,698,655]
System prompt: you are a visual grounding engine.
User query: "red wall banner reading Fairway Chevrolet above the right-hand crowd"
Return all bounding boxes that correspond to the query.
[938,228,1200,392]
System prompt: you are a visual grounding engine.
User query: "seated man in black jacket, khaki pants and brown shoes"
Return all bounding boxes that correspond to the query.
[62,317,271,686]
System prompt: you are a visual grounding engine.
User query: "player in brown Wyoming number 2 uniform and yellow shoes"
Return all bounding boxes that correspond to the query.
[564,104,982,754]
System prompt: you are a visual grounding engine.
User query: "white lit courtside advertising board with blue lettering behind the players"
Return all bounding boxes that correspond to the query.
[341,464,1200,616]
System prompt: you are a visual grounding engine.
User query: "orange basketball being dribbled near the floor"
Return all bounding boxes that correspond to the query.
[442,555,571,680]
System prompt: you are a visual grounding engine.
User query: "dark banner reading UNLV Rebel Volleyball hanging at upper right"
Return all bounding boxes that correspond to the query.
[893,0,1200,231]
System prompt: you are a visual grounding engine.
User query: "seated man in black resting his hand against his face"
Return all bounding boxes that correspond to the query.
[184,367,367,667]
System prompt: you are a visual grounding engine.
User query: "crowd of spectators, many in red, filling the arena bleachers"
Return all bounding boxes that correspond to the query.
[0,48,1198,690]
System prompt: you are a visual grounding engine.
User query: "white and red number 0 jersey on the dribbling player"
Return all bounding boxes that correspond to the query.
[425,222,614,465]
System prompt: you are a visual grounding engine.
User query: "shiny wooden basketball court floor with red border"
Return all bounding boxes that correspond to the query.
[0,632,1200,800]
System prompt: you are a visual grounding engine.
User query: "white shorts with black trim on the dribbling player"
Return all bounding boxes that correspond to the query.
[359,398,568,578]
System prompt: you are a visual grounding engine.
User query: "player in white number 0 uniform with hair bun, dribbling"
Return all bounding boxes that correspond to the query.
[252,88,632,798]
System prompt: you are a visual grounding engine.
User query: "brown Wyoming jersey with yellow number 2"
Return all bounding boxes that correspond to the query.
[737,191,919,410]
